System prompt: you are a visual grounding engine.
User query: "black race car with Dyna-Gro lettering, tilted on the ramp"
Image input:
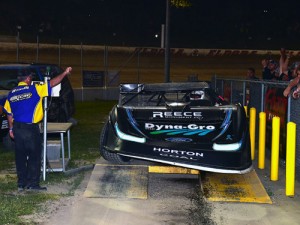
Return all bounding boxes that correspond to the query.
[100,82,252,174]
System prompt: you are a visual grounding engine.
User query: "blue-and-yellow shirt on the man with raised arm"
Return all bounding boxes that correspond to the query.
[4,82,51,123]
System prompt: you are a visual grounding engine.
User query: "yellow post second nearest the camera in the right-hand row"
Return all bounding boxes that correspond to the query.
[271,116,280,181]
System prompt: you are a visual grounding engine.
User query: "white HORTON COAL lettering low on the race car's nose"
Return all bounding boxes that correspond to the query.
[153,147,204,160]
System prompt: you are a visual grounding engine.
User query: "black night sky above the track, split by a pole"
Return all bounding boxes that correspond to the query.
[0,0,300,49]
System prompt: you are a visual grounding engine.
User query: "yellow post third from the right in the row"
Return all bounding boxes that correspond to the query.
[258,112,266,169]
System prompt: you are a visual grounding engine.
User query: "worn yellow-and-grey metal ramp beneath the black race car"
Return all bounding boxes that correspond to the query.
[84,160,272,204]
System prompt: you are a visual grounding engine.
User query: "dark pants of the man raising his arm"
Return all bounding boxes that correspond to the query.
[13,122,42,187]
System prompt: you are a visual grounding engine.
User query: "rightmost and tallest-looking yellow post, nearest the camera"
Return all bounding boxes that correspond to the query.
[285,122,297,197]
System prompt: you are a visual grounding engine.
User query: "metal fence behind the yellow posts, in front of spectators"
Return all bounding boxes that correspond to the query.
[212,75,300,180]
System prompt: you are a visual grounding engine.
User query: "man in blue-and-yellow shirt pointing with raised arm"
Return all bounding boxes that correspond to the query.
[4,67,72,191]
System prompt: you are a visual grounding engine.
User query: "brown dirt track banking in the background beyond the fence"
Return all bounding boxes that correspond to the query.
[0,42,300,88]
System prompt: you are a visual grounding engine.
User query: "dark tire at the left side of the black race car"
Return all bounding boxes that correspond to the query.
[100,121,130,164]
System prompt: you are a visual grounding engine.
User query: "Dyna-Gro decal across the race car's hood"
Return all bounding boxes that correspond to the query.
[145,123,215,136]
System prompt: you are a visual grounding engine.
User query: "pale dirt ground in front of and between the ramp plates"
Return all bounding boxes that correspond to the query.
[27,159,300,225]
